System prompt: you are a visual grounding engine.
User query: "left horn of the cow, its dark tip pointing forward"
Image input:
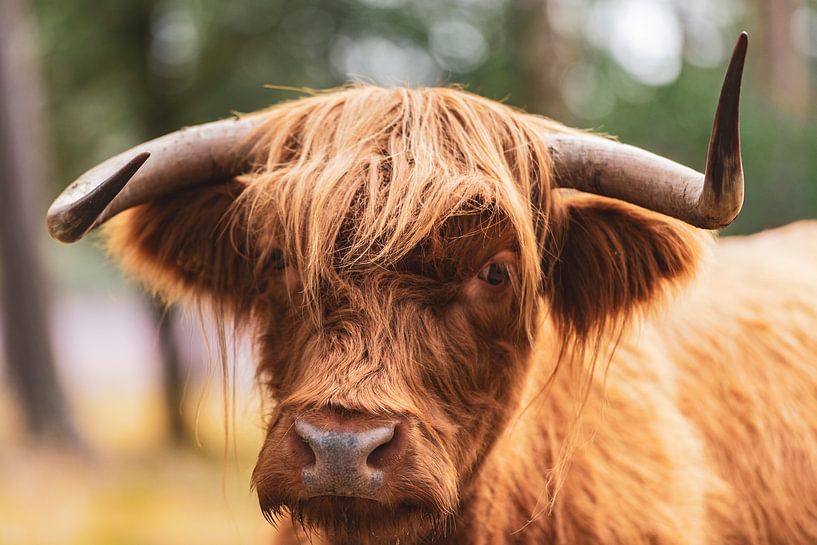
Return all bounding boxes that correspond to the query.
[46,114,267,242]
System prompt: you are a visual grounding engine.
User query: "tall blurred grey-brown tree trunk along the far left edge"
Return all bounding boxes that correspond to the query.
[0,0,78,444]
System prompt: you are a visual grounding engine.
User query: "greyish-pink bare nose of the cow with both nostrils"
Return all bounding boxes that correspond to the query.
[294,418,400,499]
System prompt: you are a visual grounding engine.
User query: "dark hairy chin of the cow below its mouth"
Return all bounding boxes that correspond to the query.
[261,496,448,545]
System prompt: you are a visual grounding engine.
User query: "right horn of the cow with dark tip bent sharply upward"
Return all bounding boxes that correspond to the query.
[547,32,748,229]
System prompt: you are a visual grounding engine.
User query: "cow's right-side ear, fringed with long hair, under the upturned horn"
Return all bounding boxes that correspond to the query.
[545,195,711,338]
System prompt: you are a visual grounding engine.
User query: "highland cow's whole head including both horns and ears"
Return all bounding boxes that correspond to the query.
[44,33,746,542]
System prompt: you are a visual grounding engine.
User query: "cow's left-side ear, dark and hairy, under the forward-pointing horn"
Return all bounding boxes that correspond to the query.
[104,181,254,310]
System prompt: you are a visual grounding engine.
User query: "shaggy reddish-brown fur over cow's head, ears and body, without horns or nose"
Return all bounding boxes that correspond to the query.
[102,87,817,545]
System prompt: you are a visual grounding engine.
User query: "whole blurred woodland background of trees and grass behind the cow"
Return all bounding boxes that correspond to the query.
[0,0,817,545]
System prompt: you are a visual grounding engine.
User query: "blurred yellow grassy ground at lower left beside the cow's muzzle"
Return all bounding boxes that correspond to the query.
[0,382,271,545]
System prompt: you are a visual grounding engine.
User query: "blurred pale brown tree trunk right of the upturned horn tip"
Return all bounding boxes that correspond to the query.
[755,0,813,115]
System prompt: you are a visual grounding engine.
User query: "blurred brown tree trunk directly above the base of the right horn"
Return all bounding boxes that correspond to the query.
[512,0,576,119]
